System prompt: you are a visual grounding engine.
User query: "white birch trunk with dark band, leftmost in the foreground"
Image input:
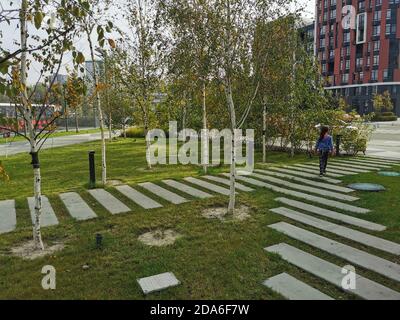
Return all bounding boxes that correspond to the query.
[20,0,44,250]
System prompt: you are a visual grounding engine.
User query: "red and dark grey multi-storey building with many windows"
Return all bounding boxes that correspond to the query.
[305,0,400,116]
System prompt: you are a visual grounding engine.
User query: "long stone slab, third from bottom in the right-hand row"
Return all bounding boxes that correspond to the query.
[268,222,400,281]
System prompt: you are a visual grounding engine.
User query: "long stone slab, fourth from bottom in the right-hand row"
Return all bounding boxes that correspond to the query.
[270,207,400,255]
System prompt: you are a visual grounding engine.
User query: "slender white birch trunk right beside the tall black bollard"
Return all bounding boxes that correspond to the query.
[86,29,107,185]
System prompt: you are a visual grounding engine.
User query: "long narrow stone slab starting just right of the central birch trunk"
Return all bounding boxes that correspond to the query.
[227,176,370,213]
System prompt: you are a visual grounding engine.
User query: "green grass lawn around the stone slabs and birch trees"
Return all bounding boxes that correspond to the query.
[0,139,400,299]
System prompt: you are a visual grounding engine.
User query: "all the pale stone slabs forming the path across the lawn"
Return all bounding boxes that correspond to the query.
[0,157,400,300]
